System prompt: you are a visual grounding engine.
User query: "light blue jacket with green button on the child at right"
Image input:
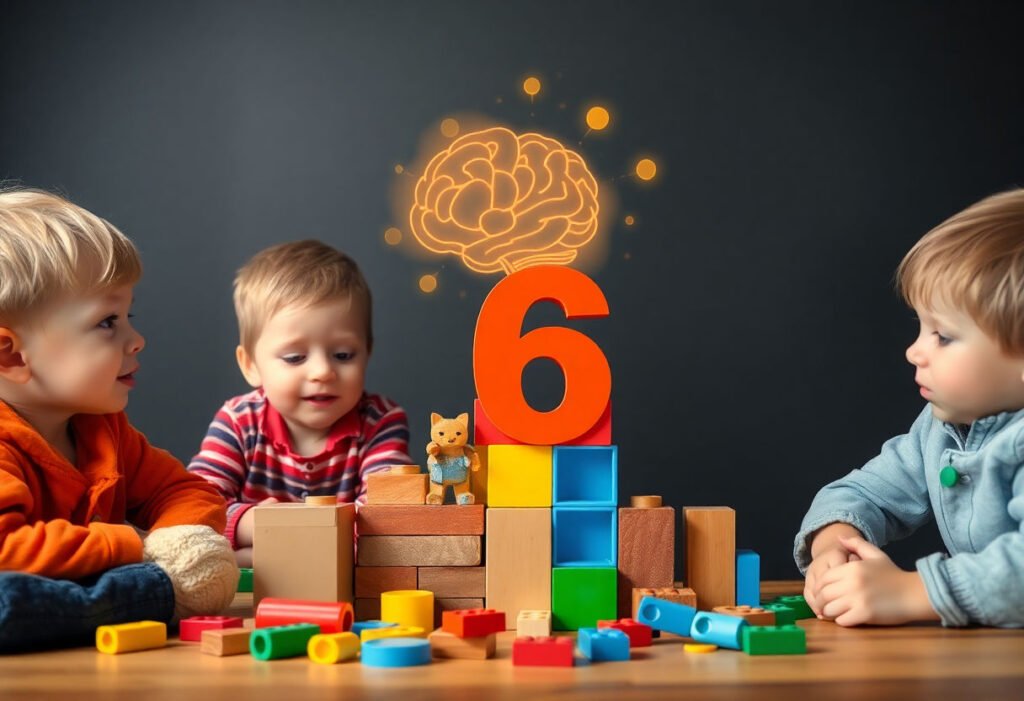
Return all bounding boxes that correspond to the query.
[794,404,1024,627]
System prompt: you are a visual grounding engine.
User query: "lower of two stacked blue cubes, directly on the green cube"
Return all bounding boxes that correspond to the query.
[551,507,618,567]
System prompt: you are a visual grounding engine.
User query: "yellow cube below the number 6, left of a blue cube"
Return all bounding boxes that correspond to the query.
[487,445,551,507]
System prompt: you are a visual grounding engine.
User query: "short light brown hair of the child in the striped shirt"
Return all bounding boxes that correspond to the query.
[234,239,374,354]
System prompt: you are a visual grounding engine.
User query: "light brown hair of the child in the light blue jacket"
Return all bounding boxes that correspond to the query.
[896,188,1024,355]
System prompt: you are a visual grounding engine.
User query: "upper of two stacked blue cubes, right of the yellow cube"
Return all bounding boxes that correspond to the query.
[551,445,618,507]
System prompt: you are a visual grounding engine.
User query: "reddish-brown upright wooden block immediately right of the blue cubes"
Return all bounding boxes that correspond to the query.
[618,507,676,618]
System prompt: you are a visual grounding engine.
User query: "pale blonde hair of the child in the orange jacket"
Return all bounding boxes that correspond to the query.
[0,187,142,324]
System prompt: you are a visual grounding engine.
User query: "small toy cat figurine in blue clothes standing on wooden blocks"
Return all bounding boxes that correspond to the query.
[427,413,480,506]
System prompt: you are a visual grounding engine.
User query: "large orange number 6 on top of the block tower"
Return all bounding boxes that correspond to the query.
[473,265,611,445]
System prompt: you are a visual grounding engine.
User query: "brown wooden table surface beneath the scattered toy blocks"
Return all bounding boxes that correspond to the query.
[0,582,1024,701]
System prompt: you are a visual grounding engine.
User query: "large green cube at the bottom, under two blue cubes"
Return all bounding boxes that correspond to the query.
[551,567,617,630]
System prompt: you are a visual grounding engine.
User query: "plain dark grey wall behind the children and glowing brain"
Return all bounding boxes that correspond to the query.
[0,2,1024,578]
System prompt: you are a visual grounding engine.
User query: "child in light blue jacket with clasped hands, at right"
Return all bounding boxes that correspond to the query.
[795,189,1024,627]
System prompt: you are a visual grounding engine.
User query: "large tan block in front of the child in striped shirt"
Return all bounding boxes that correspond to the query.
[253,503,355,609]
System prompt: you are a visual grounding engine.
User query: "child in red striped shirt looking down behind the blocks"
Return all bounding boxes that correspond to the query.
[188,240,411,567]
